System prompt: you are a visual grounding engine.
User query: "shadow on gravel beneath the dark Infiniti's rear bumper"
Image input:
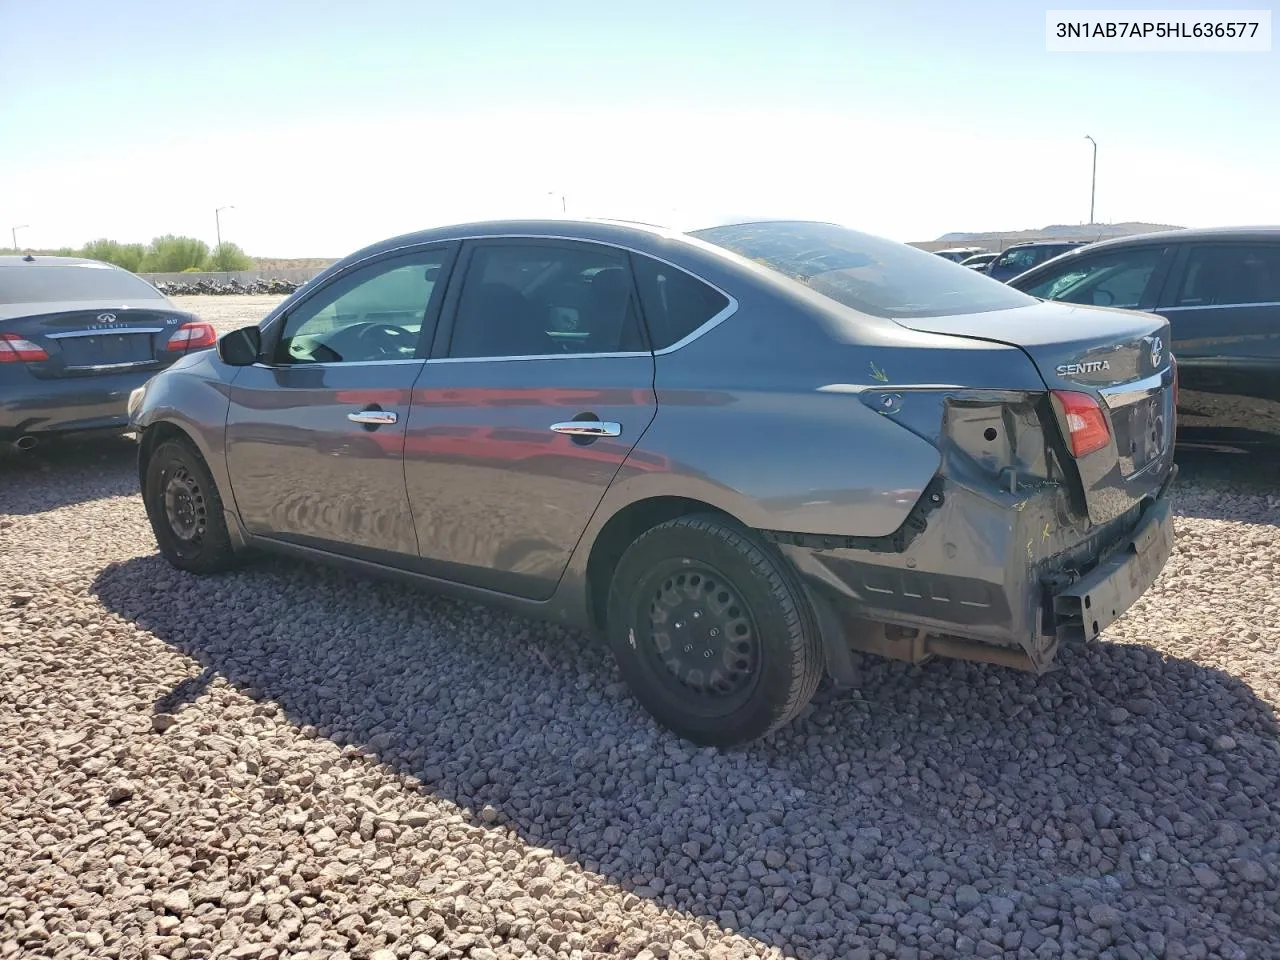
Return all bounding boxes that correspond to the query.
[0,436,138,516]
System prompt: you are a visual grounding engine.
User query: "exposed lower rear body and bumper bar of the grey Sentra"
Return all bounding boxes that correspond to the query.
[777,468,1176,680]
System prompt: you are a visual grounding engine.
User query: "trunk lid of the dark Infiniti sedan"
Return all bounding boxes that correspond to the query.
[0,301,196,380]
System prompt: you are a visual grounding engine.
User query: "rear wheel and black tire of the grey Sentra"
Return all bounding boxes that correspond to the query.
[607,515,823,746]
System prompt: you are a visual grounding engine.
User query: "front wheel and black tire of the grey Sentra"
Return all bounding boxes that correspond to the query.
[142,439,238,573]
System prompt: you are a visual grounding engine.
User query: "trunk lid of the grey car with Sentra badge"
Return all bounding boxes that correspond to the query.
[896,302,1175,524]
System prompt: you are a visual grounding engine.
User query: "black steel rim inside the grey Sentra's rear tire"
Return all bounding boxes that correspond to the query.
[648,564,759,699]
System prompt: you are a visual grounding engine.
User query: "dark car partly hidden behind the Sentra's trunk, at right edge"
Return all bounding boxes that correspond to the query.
[1010,227,1280,448]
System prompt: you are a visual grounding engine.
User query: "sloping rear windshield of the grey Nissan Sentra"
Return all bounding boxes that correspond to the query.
[690,221,1036,319]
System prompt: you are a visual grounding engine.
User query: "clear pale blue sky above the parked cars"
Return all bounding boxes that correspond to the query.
[0,0,1280,257]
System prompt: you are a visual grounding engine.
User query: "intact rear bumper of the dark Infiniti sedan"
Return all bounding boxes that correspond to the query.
[0,370,156,442]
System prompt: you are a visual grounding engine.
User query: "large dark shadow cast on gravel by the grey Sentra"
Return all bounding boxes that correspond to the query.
[92,556,1280,956]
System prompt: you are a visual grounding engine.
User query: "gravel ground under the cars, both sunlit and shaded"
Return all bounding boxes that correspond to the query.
[0,297,1280,960]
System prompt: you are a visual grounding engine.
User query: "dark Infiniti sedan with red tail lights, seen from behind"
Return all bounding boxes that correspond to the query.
[0,255,216,449]
